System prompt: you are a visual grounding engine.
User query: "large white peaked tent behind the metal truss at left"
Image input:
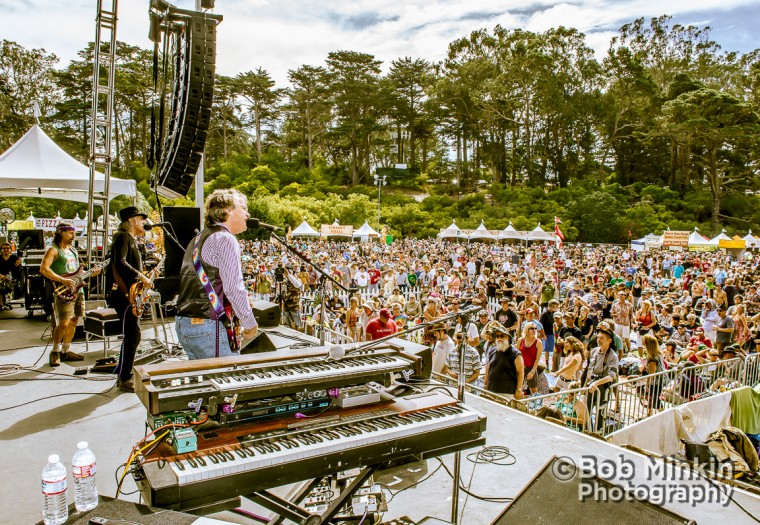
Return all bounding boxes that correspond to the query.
[0,125,137,202]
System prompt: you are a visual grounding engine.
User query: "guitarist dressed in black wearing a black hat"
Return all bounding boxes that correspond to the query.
[107,206,151,392]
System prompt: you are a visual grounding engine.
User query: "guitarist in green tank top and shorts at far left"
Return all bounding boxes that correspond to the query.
[40,222,93,366]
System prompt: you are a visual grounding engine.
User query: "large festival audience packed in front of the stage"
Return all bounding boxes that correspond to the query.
[235,235,760,424]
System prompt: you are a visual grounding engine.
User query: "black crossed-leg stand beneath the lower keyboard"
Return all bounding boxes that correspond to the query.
[246,463,381,525]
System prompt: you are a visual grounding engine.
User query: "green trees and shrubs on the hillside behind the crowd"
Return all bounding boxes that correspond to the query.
[0,16,760,242]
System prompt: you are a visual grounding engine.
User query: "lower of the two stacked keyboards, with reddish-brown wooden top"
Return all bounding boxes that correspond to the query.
[136,392,486,510]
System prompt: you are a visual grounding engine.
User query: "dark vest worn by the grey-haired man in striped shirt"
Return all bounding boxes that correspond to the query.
[177,226,227,319]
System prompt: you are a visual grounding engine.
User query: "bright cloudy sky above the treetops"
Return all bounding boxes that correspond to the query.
[0,0,760,87]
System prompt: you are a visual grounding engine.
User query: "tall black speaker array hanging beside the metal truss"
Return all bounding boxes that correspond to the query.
[151,0,222,198]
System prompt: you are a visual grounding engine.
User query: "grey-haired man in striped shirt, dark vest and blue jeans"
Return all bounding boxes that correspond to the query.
[175,186,258,359]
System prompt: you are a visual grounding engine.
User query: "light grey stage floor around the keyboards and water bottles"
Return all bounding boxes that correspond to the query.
[0,318,760,525]
